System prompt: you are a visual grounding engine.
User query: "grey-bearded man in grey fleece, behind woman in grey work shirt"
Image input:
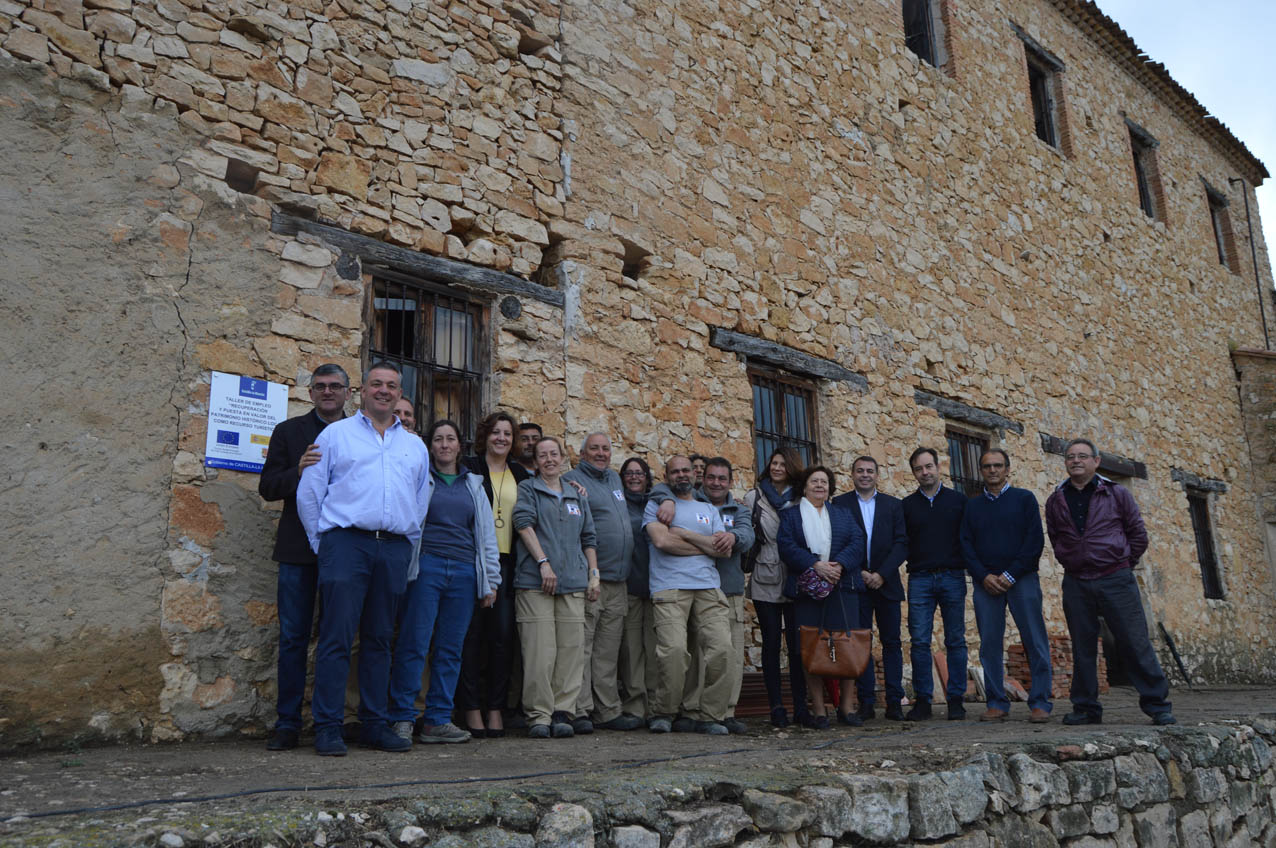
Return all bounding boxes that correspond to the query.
[563,432,642,733]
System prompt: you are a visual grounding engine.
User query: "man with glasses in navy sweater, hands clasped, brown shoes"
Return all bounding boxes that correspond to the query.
[961,448,1053,724]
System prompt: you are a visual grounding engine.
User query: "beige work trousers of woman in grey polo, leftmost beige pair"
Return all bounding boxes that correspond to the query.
[514,589,584,724]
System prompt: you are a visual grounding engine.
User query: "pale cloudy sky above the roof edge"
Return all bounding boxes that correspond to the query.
[1096,0,1276,284]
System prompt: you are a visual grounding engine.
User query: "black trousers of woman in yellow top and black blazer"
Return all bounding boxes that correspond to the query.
[457,553,519,710]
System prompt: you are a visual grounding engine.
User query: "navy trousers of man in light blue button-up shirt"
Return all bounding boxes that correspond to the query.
[310,529,412,731]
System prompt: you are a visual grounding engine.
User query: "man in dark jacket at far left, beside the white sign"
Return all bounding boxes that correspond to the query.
[256,363,350,751]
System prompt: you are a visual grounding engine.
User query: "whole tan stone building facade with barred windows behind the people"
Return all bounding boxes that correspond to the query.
[0,0,1276,747]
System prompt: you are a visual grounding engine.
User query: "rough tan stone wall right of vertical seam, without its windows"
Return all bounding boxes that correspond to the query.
[563,1,1276,680]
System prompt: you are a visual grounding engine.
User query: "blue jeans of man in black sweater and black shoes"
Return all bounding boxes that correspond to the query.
[909,569,966,704]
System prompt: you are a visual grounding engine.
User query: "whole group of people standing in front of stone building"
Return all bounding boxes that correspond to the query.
[260,362,1174,755]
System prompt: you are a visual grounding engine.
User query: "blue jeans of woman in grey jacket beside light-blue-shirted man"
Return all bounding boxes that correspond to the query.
[389,553,479,724]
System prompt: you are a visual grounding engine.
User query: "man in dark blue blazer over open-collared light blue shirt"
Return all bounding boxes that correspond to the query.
[833,457,909,722]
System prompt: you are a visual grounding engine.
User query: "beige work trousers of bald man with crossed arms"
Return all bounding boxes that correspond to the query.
[651,589,732,722]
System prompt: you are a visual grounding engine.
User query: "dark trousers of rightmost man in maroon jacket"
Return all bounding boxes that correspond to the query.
[1063,569,1170,717]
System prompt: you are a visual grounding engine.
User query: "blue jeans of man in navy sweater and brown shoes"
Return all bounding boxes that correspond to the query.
[975,573,1051,713]
